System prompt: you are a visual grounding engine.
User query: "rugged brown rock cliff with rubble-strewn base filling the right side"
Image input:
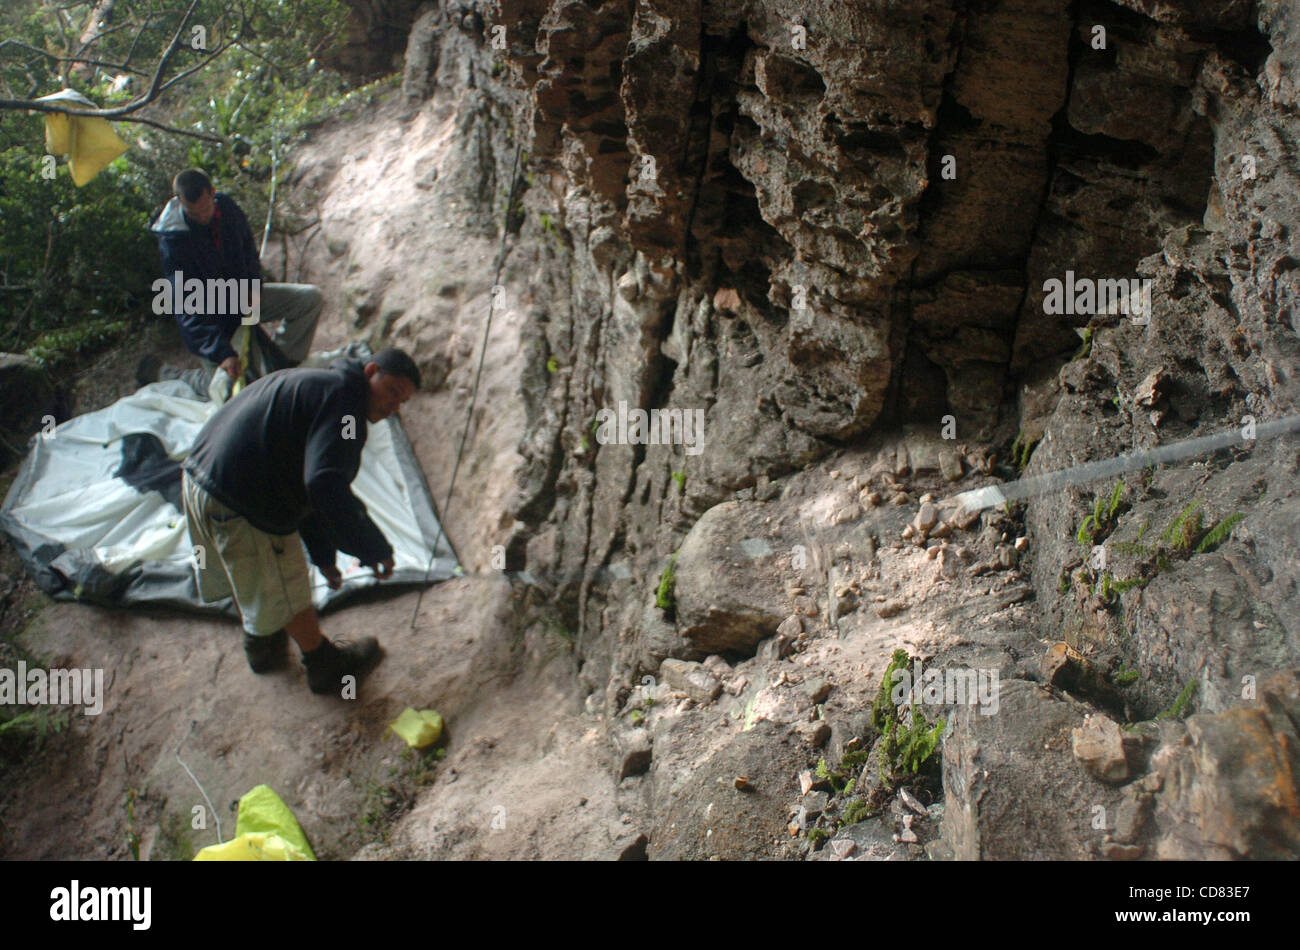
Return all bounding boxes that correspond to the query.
[330,0,1300,859]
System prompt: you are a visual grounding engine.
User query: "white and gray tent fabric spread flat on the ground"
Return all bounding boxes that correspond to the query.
[0,344,463,616]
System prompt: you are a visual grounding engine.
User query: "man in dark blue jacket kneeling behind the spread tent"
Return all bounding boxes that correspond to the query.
[137,169,324,396]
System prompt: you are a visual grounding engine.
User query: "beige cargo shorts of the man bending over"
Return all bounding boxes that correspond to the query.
[181,472,312,637]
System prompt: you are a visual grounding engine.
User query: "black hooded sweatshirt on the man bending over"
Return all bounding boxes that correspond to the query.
[185,359,393,568]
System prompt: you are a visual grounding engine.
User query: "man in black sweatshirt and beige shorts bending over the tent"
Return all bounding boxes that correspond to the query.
[181,350,420,693]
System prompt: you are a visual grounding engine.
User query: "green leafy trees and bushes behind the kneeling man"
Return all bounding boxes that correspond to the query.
[0,0,361,366]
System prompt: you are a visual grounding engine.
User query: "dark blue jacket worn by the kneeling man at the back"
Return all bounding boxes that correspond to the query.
[150,191,261,363]
